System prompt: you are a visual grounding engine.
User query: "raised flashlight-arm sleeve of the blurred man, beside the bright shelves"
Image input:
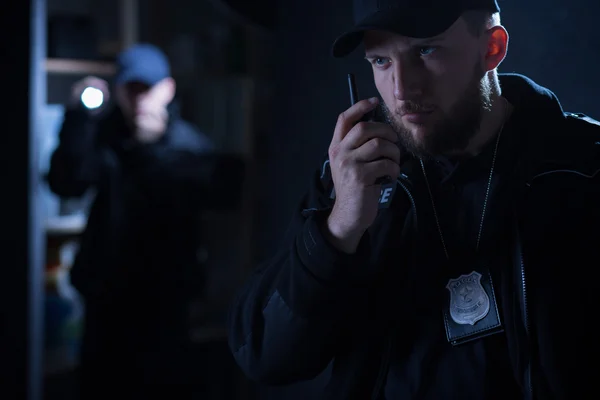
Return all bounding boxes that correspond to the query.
[47,110,101,197]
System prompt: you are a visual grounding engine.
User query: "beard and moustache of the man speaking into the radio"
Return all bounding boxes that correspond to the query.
[381,61,492,158]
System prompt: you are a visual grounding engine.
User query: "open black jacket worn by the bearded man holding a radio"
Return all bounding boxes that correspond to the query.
[229,75,600,400]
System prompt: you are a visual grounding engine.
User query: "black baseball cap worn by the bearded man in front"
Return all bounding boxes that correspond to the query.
[332,0,500,57]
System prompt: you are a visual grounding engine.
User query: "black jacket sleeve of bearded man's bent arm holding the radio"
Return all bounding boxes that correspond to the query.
[229,155,376,385]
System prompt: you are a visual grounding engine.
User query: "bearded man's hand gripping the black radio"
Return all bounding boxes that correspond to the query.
[325,98,400,253]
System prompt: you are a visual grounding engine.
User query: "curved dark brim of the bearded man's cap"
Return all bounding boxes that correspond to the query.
[332,10,460,58]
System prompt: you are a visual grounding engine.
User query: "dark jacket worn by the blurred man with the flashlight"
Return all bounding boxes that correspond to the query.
[48,107,241,303]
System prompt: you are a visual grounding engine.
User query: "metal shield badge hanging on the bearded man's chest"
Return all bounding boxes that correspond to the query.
[446,271,490,325]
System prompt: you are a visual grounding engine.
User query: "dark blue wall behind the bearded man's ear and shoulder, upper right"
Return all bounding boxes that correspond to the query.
[500,0,600,113]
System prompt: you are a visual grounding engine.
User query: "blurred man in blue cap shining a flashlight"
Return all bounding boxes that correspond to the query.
[48,44,216,400]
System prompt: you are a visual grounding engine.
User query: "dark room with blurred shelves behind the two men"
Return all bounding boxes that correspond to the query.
[0,0,600,400]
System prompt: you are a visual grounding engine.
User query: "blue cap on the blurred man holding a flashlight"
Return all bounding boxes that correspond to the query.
[115,44,171,86]
